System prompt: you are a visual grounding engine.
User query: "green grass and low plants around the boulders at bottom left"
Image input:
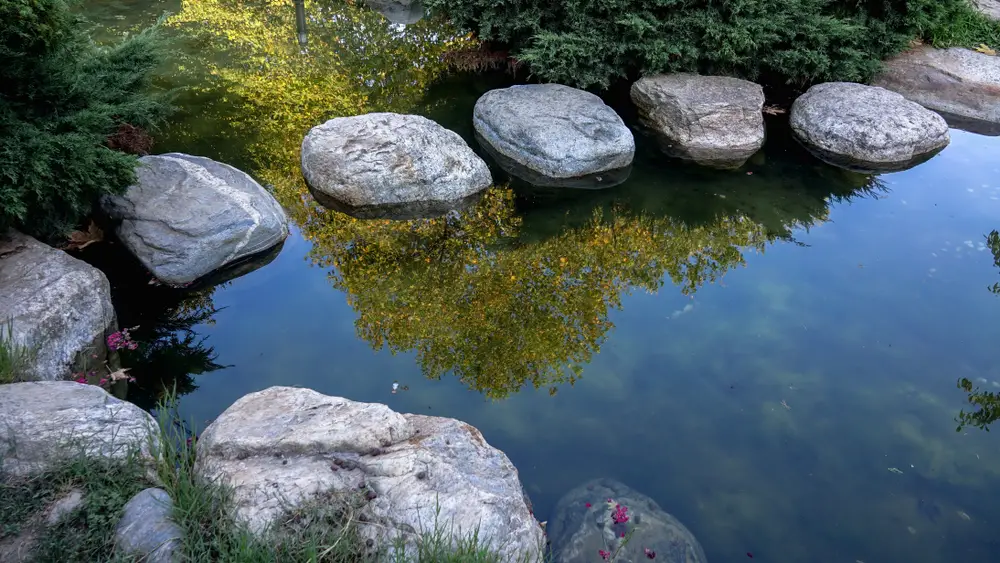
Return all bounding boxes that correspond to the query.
[0,394,533,563]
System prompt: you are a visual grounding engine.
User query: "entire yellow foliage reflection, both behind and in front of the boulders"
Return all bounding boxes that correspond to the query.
[170,0,860,398]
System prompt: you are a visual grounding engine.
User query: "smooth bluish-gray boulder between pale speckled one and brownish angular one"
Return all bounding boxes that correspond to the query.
[473,84,635,178]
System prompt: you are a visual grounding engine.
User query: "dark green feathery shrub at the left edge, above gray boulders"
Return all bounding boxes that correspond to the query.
[0,0,168,237]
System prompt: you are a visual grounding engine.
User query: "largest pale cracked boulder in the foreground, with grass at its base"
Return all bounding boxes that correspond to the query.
[195,387,544,561]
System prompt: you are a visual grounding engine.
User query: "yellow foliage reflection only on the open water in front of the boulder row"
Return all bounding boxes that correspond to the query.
[297,188,768,398]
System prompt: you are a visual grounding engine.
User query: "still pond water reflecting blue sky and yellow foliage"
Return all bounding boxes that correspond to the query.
[85,0,1000,563]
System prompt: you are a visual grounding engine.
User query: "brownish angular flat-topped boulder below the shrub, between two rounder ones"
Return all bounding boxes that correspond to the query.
[631,73,764,168]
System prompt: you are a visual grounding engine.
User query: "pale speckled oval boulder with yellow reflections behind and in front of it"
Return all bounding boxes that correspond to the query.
[302,113,493,215]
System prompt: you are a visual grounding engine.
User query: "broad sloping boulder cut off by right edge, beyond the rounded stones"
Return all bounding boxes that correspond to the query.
[873,46,1000,135]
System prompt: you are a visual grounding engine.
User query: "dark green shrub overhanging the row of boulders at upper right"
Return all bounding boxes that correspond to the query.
[425,0,1000,87]
